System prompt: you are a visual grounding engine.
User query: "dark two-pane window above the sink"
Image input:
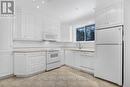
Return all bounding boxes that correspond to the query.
[76,24,95,41]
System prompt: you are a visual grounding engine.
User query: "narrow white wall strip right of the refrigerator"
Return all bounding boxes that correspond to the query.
[124,0,130,87]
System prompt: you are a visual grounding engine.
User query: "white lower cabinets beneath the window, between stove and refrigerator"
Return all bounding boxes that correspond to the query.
[65,50,95,73]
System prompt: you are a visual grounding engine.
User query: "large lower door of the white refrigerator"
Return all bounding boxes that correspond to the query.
[95,45,122,85]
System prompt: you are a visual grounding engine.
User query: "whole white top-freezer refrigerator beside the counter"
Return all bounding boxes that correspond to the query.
[95,26,123,85]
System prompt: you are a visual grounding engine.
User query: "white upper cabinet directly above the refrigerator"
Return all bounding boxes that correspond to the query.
[96,0,124,29]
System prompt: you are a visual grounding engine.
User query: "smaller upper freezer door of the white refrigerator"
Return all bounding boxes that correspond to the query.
[96,27,123,44]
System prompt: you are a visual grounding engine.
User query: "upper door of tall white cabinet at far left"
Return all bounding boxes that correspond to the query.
[0,17,13,50]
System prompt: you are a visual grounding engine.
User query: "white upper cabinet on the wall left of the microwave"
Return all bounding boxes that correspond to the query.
[22,15,42,41]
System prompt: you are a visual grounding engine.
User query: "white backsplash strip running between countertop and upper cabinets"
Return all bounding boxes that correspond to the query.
[13,41,95,49]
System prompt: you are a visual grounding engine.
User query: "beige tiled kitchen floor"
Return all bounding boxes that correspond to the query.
[0,67,118,87]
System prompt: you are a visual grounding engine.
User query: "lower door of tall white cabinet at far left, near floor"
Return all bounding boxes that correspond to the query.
[0,52,13,78]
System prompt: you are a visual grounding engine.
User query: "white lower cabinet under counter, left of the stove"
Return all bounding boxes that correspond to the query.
[14,52,46,76]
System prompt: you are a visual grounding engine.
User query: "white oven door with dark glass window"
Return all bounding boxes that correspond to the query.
[47,52,60,64]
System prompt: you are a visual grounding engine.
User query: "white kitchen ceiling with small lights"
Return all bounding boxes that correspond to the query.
[16,0,96,22]
